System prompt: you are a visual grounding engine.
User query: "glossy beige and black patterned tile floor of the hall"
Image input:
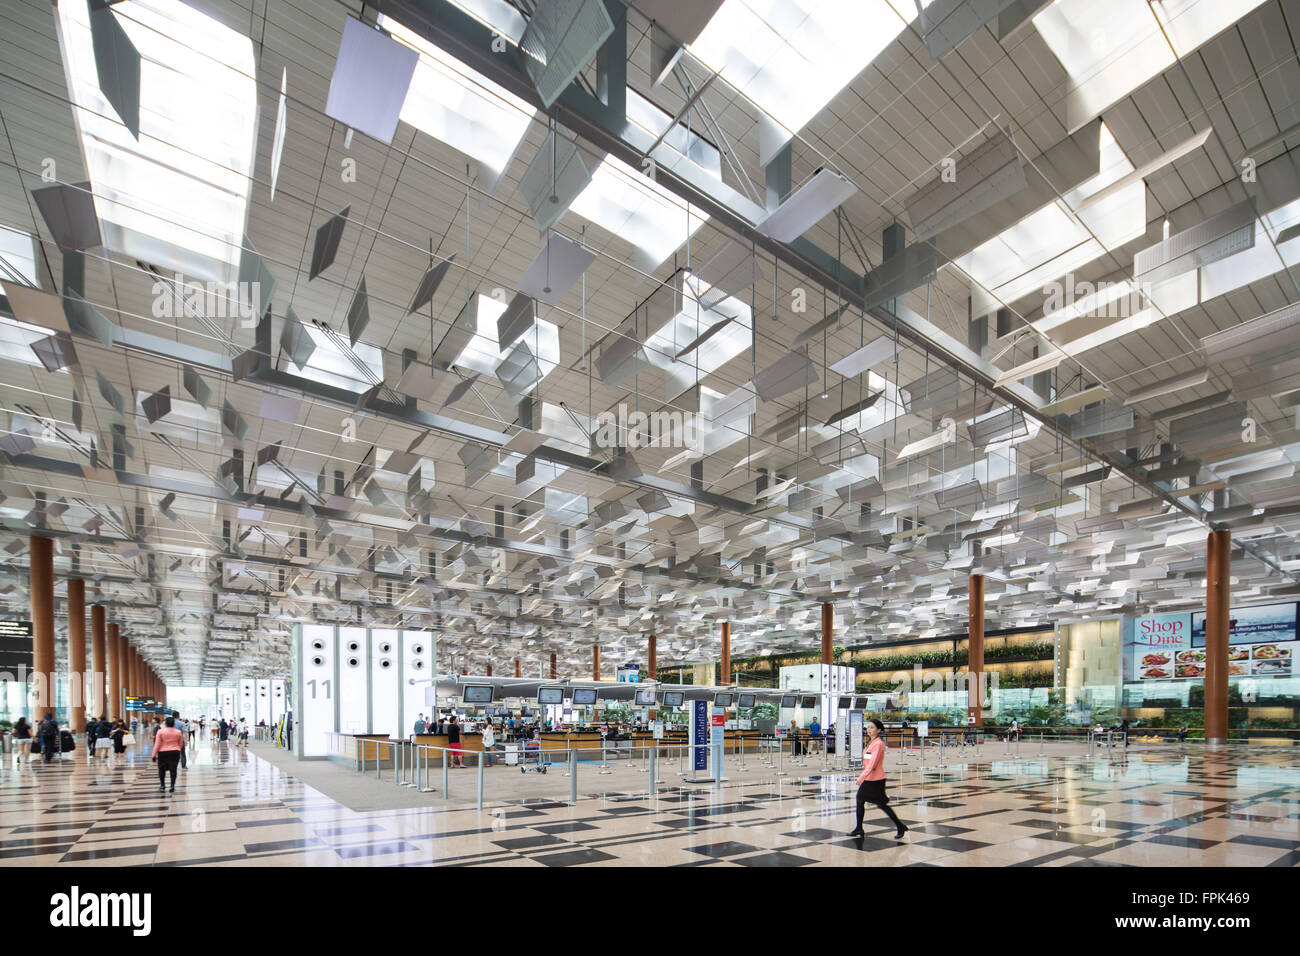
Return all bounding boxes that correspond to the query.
[0,744,1300,866]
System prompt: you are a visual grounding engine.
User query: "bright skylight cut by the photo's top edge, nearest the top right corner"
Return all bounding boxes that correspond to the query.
[1034,0,1264,133]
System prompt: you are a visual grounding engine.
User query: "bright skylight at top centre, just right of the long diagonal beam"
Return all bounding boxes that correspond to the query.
[690,0,930,135]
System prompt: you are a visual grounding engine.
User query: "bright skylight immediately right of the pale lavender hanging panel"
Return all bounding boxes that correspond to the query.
[380,13,534,179]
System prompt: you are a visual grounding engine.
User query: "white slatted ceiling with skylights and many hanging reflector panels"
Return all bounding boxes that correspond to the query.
[0,0,1300,685]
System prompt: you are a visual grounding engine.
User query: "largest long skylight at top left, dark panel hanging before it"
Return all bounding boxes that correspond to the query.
[56,0,257,281]
